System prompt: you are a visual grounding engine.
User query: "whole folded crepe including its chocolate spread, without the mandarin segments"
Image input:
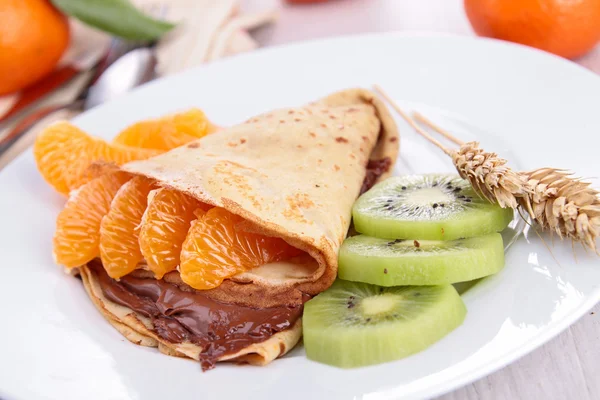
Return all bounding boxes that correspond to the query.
[79,89,399,369]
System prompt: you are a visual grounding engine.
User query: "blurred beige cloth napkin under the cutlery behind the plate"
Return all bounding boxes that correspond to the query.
[0,0,277,168]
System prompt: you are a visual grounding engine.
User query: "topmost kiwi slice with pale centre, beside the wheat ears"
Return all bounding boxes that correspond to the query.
[352,175,513,240]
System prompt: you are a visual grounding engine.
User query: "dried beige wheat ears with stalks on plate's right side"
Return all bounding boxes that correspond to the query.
[375,86,600,255]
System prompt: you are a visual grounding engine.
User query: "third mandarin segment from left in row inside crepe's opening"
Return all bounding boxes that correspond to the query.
[139,188,210,279]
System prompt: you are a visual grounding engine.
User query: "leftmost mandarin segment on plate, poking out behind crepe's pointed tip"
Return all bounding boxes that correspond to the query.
[33,121,161,194]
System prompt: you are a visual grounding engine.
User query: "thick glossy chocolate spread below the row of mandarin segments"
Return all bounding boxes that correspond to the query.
[88,261,303,371]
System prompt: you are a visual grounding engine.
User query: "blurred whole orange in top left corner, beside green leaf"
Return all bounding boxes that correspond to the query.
[0,0,69,95]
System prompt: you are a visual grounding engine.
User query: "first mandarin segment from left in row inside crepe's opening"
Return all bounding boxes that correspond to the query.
[54,172,130,268]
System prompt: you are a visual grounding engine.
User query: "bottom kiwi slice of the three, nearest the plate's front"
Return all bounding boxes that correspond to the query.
[303,280,467,368]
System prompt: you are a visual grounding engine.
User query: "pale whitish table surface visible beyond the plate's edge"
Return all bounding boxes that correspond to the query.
[242,0,600,400]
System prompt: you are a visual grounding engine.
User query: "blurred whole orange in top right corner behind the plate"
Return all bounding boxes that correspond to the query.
[464,0,600,58]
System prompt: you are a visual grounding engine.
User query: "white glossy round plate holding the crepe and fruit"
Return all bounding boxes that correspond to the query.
[0,34,600,400]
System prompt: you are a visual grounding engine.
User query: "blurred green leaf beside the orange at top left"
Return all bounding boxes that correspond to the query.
[52,0,174,40]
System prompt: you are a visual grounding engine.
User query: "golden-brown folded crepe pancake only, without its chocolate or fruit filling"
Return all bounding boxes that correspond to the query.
[81,89,399,364]
